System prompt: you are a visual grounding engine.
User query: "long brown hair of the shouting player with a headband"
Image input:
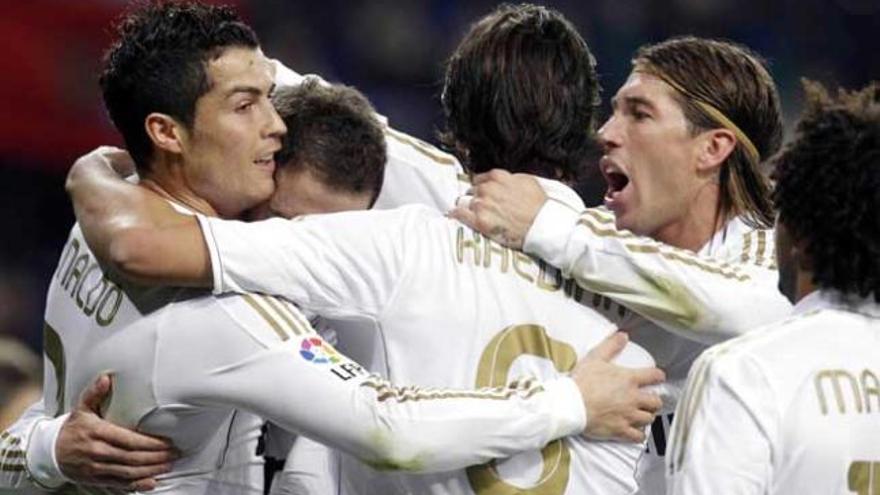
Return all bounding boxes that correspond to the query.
[633,36,783,227]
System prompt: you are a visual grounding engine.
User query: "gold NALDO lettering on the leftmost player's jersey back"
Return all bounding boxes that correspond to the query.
[55,239,123,327]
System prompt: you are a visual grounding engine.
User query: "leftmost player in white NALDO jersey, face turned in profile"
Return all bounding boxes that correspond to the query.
[0,4,632,493]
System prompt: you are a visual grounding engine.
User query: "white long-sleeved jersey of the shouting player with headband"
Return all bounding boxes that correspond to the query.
[524,201,791,494]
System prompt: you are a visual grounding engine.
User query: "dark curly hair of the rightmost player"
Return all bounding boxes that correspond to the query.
[773,81,880,302]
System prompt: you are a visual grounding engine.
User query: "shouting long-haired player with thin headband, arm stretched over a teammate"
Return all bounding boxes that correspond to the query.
[455,37,790,493]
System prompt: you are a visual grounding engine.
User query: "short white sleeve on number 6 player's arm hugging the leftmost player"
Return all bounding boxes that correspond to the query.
[199,209,422,318]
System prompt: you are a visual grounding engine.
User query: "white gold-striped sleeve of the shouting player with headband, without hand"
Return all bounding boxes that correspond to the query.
[524,201,791,344]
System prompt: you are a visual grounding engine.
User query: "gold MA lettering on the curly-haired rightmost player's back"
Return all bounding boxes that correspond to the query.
[814,369,880,416]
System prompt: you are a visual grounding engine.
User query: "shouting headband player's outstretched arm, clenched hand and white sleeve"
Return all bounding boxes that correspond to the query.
[453,170,791,344]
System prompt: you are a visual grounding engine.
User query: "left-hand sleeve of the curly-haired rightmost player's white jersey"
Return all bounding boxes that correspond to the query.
[666,348,777,495]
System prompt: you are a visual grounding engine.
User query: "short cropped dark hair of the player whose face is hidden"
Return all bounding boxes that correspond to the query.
[272,79,386,205]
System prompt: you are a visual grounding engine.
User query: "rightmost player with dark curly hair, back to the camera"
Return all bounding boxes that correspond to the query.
[667,83,880,495]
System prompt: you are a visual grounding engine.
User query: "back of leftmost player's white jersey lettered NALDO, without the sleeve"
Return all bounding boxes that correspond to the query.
[43,226,262,493]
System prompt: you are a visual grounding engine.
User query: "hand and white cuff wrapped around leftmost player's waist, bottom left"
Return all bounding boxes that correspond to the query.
[0,376,177,491]
